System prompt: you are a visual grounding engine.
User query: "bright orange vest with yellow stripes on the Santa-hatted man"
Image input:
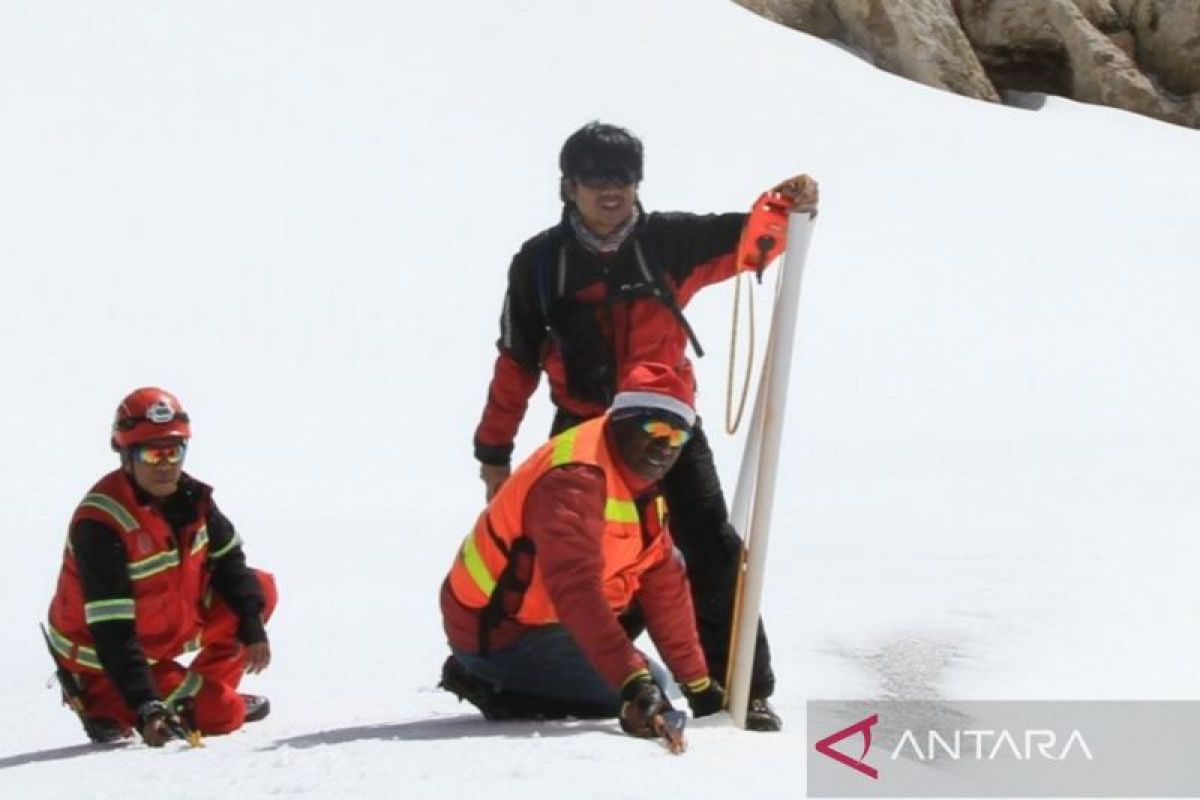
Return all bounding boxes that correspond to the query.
[449,417,670,652]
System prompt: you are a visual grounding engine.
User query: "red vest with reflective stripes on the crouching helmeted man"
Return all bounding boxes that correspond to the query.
[49,470,222,673]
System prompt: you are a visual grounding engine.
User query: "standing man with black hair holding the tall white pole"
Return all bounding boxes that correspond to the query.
[474,122,817,730]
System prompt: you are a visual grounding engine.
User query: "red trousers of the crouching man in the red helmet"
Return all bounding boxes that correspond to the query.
[77,570,278,734]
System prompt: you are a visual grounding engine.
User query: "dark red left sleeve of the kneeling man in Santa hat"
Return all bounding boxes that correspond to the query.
[523,464,646,688]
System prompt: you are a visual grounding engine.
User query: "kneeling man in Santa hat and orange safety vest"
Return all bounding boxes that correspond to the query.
[440,363,724,736]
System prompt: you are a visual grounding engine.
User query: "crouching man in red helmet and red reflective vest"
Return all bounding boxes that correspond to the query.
[47,387,276,747]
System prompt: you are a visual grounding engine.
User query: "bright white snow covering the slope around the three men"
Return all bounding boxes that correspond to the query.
[0,0,1200,800]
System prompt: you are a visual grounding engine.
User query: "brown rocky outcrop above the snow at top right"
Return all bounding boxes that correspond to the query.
[736,0,1200,128]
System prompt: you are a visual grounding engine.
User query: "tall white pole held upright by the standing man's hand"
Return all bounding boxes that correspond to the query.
[726,213,814,728]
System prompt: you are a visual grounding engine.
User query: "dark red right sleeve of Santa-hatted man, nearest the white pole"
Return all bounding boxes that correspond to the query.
[637,535,709,684]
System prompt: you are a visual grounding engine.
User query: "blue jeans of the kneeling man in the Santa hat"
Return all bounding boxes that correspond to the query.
[451,625,668,716]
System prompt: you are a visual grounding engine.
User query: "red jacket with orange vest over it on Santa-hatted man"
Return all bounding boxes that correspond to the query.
[442,420,708,687]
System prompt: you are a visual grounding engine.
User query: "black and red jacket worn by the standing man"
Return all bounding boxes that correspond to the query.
[475,211,763,464]
